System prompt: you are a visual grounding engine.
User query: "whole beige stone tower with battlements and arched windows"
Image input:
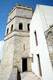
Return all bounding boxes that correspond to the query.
[1,3,33,77]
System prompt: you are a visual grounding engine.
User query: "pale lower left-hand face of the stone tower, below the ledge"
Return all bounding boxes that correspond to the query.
[1,37,14,77]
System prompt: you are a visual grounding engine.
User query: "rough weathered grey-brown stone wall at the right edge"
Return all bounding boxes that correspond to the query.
[45,26,53,67]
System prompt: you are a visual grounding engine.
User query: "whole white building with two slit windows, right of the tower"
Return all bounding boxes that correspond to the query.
[30,5,53,80]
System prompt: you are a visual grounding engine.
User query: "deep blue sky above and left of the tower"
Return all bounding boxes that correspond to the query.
[0,0,53,41]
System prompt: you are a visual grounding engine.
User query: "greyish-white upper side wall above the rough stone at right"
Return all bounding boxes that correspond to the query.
[38,5,53,32]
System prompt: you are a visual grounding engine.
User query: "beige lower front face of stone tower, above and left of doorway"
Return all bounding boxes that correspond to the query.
[13,35,30,72]
